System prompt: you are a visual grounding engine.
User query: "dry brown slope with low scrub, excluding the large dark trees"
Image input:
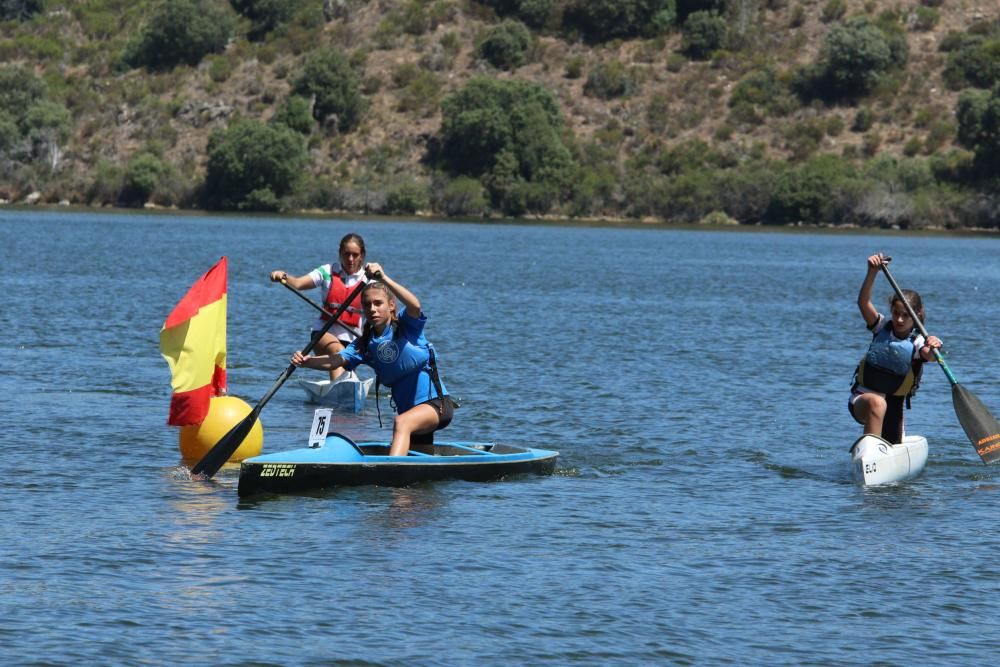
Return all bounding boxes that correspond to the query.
[0,0,1000,227]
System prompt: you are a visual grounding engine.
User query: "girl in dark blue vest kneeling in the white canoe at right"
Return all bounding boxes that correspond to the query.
[848,254,941,444]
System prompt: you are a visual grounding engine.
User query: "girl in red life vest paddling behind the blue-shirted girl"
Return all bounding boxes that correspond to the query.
[271,234,365,380]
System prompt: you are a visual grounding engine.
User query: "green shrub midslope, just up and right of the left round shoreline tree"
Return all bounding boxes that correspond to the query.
[292,47,365,132]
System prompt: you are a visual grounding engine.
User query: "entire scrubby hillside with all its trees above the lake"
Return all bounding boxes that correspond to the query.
[0,0,1000,229]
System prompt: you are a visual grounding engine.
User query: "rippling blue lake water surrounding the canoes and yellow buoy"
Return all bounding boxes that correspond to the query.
[0,210,1000,665]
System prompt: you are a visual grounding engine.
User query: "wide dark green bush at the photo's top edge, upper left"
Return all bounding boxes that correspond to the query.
[122,0,233,70]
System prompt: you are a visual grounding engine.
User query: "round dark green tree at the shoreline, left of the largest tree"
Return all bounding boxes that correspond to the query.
[205,120,309,211]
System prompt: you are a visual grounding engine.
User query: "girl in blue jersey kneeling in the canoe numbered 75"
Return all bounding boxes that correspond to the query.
[292,262,454,456]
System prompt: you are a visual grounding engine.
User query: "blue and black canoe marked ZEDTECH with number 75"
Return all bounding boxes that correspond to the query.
[238,433,559,496]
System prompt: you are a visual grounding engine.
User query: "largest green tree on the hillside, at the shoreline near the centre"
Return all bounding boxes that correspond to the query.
[440,77,573,215]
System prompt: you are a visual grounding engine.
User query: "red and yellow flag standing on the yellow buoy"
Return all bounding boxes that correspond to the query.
[160,257,227,426]
